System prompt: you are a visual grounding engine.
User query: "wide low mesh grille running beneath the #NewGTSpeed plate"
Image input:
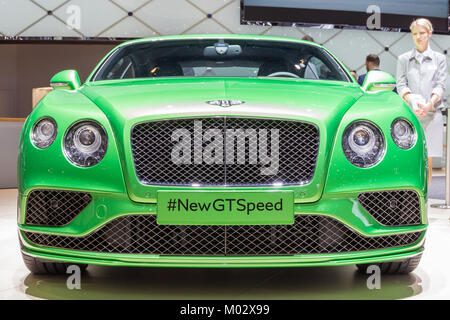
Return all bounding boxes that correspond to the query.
[25,215,421,256]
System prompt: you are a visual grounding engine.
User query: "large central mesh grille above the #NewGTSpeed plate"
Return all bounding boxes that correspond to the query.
[131,117,319,186]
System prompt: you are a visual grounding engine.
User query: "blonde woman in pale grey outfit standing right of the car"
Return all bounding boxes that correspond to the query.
[397,18,450,181]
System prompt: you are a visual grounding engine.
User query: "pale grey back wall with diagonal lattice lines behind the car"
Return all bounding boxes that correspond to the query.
[0,0,450,97]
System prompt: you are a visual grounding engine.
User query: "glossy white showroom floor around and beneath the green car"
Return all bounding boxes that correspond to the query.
[0,189,450,300]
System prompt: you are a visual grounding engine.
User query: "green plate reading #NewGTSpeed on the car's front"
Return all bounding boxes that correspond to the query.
[157,191,294,225]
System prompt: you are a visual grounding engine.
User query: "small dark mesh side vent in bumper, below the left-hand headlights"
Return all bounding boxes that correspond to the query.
[25,190,92,227]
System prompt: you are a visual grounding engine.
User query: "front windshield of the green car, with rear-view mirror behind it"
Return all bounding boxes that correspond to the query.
[92,39,350,82]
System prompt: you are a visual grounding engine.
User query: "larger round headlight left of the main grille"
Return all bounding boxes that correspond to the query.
[64,121,108,167]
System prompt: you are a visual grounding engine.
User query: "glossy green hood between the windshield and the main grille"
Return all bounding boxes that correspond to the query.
[81,78,363,124]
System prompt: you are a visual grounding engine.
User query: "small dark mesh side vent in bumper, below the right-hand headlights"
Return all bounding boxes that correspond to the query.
[358,190,421,226]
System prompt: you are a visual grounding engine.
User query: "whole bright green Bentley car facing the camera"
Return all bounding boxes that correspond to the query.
[18,35,428,273]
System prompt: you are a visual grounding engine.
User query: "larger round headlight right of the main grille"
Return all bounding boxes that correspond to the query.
[342,121,385,168]
